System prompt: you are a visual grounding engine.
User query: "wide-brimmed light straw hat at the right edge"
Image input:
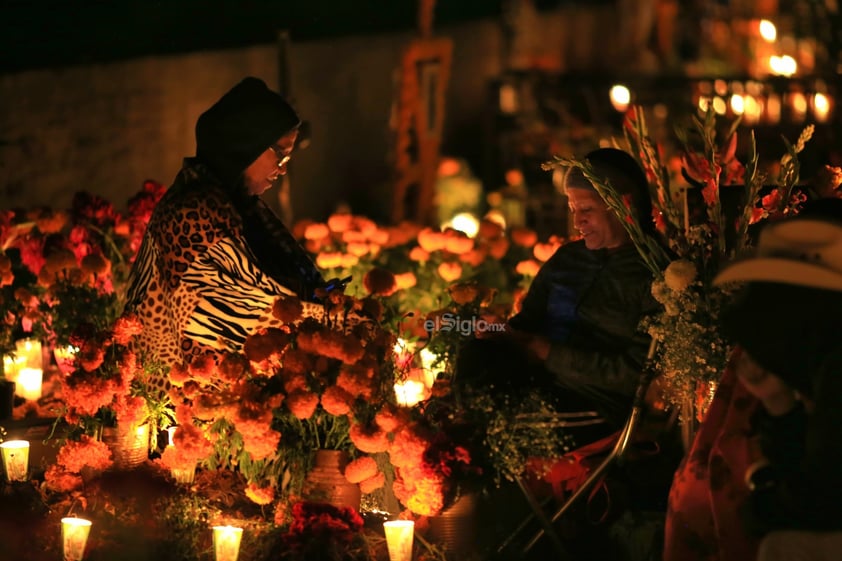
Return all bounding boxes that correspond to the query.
[714,199,842,291]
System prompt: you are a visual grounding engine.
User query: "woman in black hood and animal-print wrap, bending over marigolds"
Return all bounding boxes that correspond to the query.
[125,77,342,392]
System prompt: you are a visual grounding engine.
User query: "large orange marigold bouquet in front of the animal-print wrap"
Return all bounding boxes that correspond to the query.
[162,290,394,510]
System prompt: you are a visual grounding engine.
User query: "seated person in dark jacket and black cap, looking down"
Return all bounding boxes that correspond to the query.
[460,148,660,430]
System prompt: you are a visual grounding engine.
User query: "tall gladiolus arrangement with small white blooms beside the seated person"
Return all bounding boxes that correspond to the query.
[544,107,813,416]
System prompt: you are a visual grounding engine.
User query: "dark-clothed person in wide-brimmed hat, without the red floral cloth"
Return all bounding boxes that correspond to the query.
[716,199,842,560]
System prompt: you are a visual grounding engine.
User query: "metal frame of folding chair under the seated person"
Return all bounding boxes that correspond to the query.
[497,339,657,561]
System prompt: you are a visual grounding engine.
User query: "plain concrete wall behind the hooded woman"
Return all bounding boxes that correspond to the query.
[0,17,500,223]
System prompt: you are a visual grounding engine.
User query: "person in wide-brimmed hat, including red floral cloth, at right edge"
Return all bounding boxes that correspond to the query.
[664,199,842,561]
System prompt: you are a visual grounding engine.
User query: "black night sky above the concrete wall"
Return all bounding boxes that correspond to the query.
[0,0,624,73]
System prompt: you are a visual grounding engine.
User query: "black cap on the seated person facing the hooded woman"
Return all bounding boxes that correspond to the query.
[564,148,654,231]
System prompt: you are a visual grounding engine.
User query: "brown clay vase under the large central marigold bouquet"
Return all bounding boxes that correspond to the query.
[303,450,362,511]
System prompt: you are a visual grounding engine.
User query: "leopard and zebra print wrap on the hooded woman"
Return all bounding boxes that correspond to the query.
[125,160,324,390]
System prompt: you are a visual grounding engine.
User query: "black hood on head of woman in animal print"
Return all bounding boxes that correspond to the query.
[196,77,301,182]
